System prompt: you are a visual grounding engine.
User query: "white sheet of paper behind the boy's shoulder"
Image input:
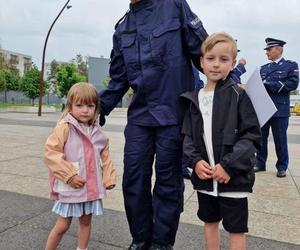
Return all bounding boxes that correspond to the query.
[245,68,277,127]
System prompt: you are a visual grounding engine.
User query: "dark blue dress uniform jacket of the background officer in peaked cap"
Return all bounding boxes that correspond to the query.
[260,58,299,117]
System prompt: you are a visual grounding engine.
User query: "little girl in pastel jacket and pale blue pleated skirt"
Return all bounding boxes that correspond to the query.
[44,83,116,250]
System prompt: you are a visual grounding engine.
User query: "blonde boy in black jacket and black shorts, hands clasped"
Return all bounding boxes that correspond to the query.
[182,33,261,250]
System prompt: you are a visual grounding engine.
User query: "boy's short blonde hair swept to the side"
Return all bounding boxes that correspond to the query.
[201,32,237,60]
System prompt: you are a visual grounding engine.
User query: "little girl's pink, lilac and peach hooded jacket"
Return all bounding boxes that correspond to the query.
[44,114,116,203]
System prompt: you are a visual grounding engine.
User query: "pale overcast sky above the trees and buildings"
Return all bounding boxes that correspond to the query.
[0,0,300,82]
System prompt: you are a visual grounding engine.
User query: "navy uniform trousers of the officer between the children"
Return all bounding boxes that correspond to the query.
[123,124,183,245]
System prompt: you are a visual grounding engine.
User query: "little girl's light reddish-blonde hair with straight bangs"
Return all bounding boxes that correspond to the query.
[60,82,100,123]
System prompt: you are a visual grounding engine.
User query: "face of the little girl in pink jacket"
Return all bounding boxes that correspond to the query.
[71,103,96,126]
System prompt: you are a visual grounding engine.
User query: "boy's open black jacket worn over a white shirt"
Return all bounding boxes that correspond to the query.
[182,79,261,192]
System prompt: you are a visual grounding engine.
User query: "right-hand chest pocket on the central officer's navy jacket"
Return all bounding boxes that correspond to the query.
[150,18,182,60]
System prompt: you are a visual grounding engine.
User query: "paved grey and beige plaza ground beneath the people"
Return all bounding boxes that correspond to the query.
[0,110,300,250]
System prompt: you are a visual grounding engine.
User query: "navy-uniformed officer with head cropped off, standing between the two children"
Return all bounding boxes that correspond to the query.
[100,0,207,250]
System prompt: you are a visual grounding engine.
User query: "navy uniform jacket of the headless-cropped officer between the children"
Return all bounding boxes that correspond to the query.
[100,0,207,126]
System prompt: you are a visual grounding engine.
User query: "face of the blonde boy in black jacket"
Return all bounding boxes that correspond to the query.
[200,42,236,82]
